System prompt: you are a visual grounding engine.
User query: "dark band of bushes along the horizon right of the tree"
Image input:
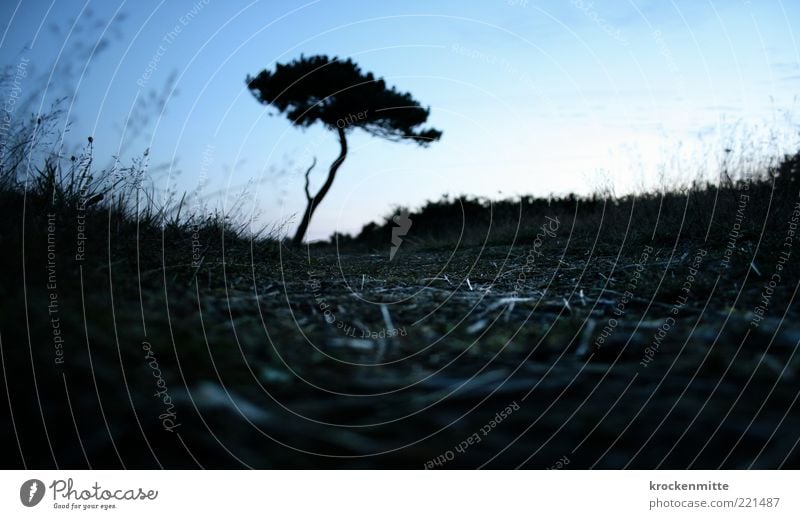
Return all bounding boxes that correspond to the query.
[340,154,800,258]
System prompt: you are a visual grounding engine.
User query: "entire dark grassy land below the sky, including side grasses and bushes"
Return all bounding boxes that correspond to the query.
[0,110,800,468]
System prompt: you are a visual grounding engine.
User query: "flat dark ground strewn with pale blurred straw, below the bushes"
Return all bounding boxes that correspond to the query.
[0,225,800,469]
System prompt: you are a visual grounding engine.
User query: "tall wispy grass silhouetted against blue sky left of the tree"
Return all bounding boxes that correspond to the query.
[0,103,282,290]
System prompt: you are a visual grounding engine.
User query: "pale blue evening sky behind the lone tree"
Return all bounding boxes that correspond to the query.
[0,0,800,239]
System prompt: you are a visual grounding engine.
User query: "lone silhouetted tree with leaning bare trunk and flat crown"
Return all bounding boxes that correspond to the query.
[247,56,442,244]
